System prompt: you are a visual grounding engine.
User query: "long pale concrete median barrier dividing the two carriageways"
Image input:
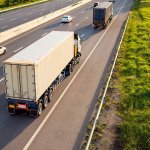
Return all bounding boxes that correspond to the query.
[0,0,92,43]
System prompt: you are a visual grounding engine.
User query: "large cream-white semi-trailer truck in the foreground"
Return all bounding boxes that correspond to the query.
[4,31,81,116]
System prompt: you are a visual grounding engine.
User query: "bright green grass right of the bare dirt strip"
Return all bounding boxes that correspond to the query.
[117,0,150,150]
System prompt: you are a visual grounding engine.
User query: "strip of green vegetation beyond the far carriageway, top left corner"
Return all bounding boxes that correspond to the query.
[0,0,48,10]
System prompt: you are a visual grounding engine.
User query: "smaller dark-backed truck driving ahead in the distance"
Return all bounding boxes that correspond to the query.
[93,2,113,29]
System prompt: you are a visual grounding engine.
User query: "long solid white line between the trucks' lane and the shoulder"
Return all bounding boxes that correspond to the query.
[23,0,127,150]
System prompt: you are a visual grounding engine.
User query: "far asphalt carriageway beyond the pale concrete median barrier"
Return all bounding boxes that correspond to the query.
[0,0,79,32]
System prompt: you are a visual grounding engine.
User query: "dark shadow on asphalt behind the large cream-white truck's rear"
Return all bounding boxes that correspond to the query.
[0,92,36,149]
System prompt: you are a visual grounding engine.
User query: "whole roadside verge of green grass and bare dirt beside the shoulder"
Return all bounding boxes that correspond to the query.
[82,0,150,150]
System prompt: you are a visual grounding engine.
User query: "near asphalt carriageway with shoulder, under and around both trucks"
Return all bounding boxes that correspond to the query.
[0,0,132,150]
